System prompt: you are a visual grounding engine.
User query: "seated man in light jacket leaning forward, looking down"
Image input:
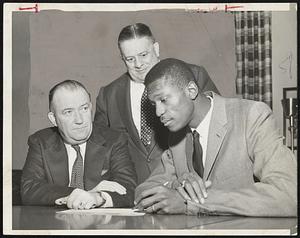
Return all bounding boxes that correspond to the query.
[135,59,297,216]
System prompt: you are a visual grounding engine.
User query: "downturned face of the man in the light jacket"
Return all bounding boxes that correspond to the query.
[148,80,194,131]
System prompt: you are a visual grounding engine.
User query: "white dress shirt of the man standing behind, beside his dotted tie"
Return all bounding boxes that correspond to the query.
[130,80,145,137]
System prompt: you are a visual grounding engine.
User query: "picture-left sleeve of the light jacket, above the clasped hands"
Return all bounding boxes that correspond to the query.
[135,150,177,197]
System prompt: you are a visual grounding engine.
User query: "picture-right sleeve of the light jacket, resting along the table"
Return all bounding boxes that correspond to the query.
[188,103,297,217]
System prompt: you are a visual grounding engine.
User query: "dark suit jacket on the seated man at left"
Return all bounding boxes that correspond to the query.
[21,127,136,207]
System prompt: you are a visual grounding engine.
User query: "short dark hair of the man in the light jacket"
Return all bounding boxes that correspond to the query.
[144,58,197,88]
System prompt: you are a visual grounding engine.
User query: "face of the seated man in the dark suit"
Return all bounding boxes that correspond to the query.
[48,88,92,144]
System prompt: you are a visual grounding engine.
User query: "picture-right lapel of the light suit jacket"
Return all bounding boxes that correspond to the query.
[203,93,227,180]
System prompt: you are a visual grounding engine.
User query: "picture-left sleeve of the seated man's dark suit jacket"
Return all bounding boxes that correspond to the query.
[21,135,74,205]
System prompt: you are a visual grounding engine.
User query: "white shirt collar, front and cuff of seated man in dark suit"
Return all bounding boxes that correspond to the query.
[64,142,113,207]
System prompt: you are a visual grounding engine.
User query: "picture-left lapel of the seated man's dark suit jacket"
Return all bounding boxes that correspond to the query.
[45,132,69,186]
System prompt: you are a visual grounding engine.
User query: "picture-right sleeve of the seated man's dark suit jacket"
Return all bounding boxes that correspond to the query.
[103,133,137,207]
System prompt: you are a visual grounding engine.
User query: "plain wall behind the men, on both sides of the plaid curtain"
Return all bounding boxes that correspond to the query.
[13,8,297,169]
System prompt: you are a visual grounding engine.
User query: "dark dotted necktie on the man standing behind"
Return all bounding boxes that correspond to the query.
[141,88,155,147]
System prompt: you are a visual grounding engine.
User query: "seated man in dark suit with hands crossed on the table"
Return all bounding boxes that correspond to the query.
[21,80,136,209]
